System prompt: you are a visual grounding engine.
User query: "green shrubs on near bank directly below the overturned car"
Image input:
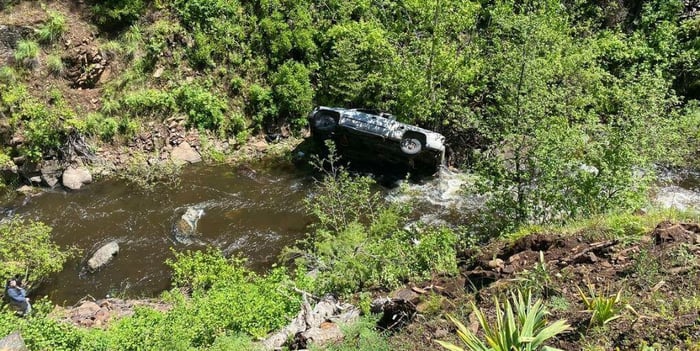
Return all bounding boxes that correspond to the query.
[288,144,457,294]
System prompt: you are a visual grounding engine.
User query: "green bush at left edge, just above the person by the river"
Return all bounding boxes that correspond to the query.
[0,218,77,284]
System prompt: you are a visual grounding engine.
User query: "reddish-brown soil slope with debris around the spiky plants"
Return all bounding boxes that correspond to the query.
[392,222,700,350]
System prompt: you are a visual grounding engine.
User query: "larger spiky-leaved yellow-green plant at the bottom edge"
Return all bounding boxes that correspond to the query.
[437,291,570,351]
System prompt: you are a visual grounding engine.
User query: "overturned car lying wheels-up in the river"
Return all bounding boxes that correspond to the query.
[308,106,445,173]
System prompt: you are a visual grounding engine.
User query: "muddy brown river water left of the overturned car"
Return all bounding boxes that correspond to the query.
[2,166,313,304]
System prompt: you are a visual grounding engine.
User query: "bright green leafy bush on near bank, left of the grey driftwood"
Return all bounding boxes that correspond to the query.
[164,251,308,344]
